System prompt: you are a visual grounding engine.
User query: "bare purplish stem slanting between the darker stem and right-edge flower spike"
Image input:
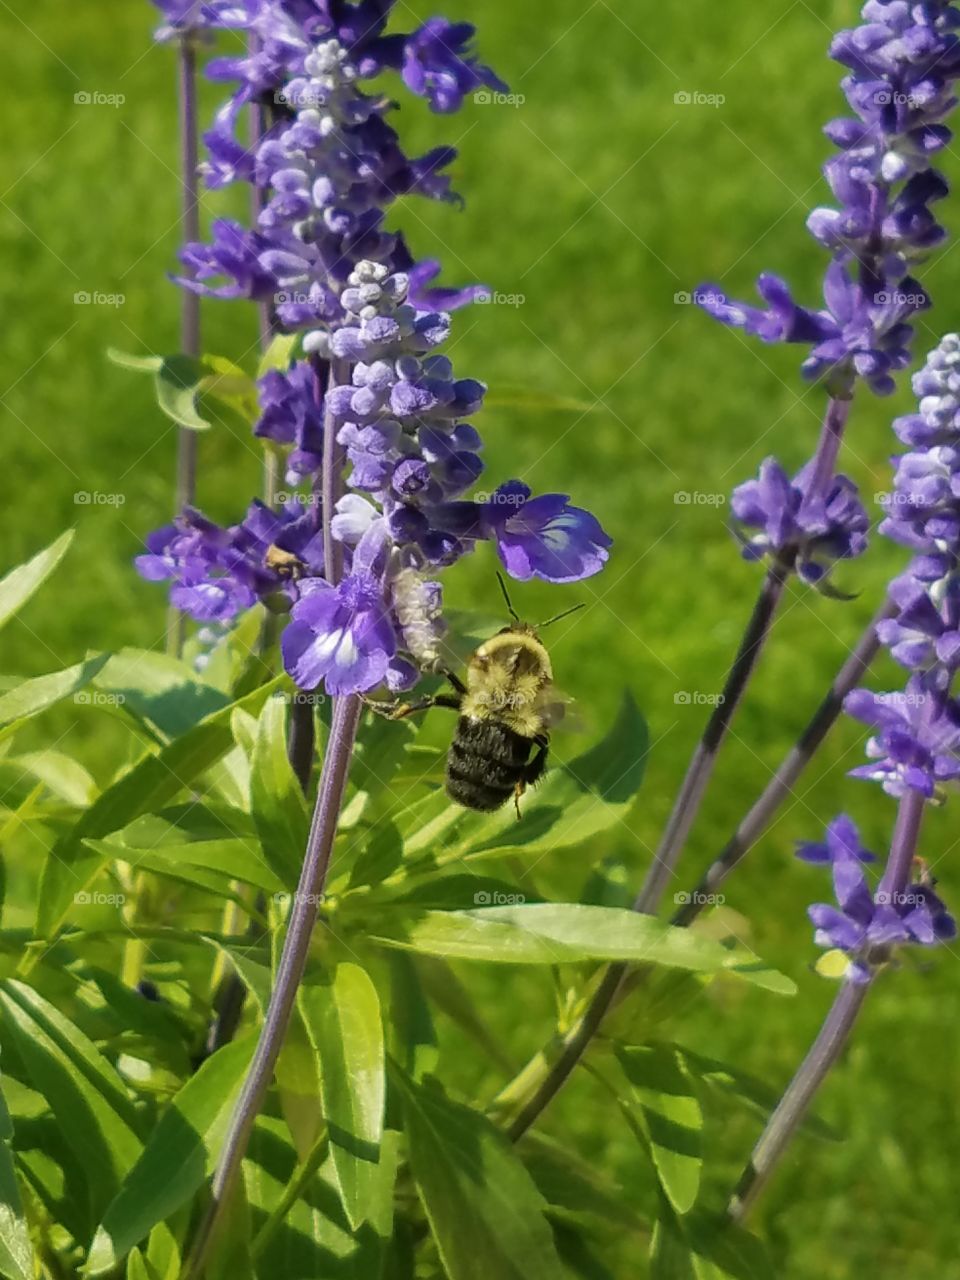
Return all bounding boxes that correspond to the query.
[671,600,896,925]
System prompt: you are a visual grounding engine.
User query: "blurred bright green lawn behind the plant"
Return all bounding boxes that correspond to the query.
[0,0,960,1280]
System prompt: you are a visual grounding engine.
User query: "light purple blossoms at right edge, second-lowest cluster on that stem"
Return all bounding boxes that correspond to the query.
[844,673,960,799]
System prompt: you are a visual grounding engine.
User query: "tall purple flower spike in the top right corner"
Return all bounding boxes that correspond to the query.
[698,0,960,396]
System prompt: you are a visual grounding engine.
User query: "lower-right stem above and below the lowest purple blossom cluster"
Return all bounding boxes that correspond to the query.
[727,790,925,1222]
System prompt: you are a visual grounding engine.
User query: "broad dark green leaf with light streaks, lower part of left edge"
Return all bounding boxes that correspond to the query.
[0,980,142,1215]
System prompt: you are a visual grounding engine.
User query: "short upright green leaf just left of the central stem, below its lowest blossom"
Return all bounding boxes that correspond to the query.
[250,696,310,890]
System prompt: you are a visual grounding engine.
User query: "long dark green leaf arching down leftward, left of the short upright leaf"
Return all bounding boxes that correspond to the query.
[37,677,289,938]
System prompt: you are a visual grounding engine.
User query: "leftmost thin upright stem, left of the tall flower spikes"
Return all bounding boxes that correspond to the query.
[166,31,201,658]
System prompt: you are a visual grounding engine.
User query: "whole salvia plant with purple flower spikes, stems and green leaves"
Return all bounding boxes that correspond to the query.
[0,0,960,1280]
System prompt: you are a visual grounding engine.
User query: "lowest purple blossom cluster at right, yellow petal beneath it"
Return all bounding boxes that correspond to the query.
[800,815,956,983]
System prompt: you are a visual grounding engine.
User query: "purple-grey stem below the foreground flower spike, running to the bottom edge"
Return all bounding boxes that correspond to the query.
[184,694,362,1277]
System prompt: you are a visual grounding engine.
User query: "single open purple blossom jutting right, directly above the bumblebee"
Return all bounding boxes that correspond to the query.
[480,480,612,582]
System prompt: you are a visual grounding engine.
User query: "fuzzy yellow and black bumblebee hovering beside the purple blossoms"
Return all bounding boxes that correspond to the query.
[369,579,582,818]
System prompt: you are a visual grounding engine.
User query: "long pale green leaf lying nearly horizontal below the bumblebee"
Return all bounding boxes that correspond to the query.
[366,902,795,992]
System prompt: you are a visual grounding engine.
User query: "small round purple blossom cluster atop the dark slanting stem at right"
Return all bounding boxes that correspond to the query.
[731,458,869,585]
